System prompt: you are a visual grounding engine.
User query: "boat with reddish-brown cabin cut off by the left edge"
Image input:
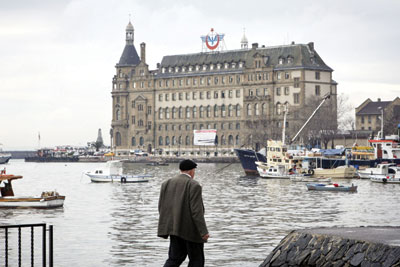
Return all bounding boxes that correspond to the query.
[0,170,65,209]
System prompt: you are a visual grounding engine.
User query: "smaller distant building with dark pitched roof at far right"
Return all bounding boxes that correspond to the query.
[355,97,400,133]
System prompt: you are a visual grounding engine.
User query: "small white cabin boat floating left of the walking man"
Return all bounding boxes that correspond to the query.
[85,160,153,183]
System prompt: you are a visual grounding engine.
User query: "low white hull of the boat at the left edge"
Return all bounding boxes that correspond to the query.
[0,196,65,209]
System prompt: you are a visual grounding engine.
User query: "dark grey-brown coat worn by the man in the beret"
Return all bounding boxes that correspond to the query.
[157,174,208,243]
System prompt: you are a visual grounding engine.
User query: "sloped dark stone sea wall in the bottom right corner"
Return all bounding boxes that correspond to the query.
[260,227,400,267]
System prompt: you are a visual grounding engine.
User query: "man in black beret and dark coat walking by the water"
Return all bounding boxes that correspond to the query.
[157,160,209,267]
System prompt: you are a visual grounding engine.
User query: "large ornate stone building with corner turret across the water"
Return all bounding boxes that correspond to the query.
[112,22,337,155]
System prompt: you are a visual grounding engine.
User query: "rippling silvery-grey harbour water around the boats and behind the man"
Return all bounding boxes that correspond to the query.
[0,160,400,267]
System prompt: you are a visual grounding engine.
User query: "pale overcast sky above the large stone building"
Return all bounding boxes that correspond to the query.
[0,0,400,150]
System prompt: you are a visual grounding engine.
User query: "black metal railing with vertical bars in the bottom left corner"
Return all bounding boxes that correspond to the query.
[0,223,53,267]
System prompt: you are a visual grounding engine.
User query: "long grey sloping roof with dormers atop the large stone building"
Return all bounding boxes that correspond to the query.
[161,44,333,75]
